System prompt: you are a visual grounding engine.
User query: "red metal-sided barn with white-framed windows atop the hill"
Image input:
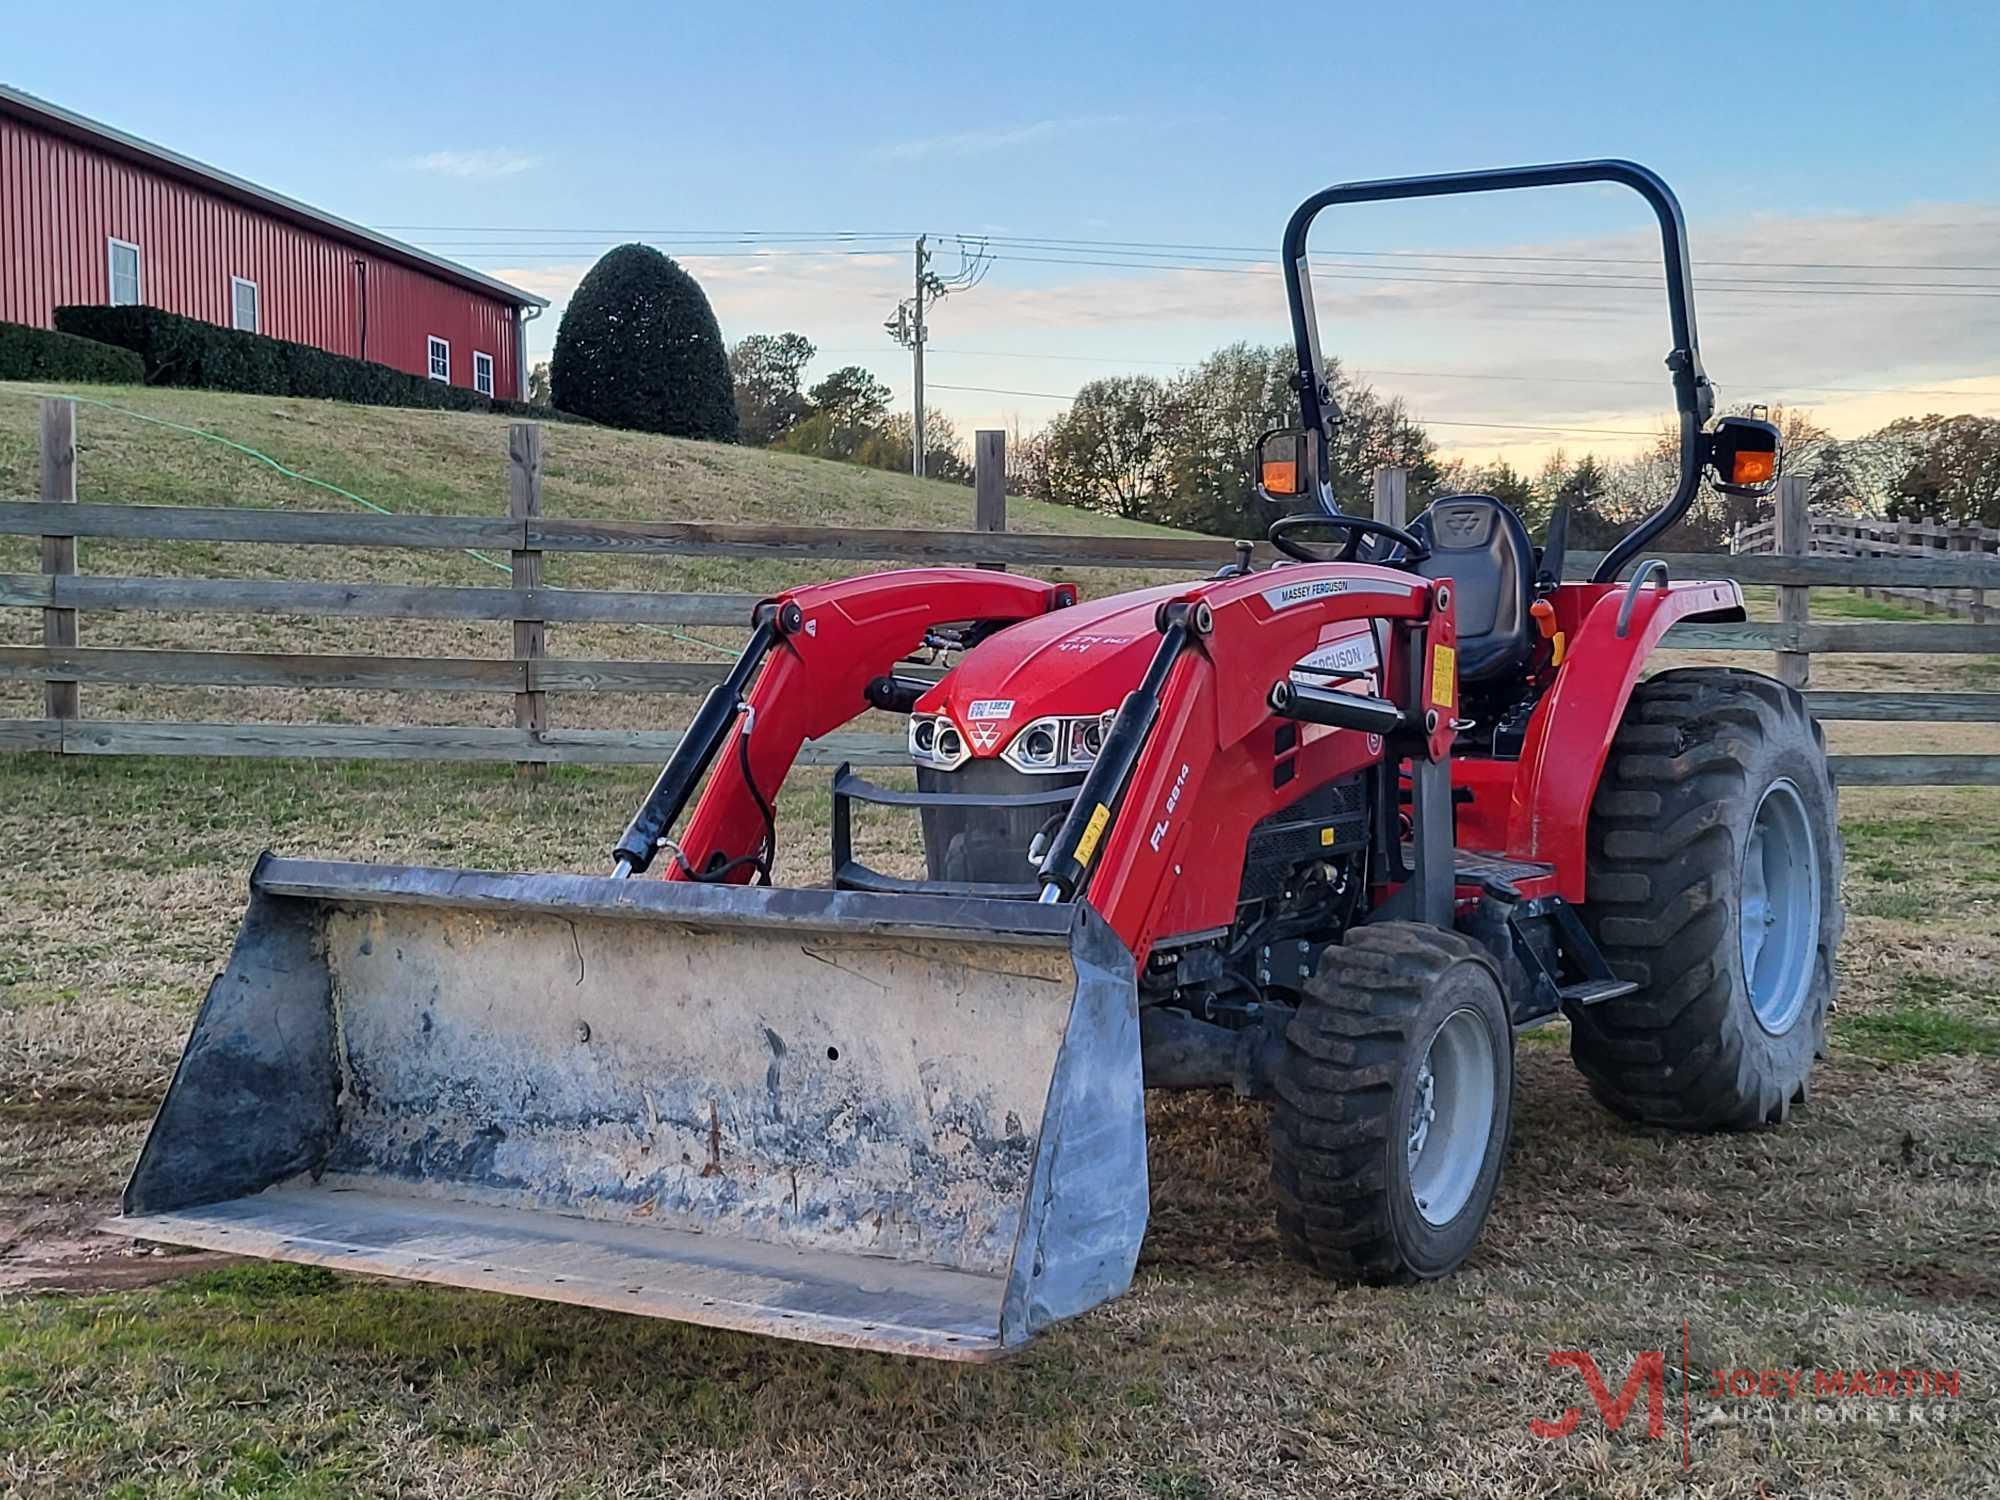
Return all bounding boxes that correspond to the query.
[0,86,548,400]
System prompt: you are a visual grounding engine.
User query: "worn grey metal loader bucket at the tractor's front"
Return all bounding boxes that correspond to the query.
[114,856,1146,1360]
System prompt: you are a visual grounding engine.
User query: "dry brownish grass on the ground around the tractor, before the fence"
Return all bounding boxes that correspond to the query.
[0,758,2000,1496]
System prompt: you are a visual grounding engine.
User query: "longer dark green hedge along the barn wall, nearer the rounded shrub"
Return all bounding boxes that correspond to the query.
[56,306,562,420]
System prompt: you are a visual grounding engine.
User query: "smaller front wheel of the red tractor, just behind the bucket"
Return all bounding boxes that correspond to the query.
[1272,922,1514,1282]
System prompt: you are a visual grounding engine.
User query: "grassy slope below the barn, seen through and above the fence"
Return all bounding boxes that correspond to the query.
[0,384,1174,728]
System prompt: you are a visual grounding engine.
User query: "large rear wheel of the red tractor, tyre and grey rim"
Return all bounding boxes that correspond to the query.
[1570,668,1844,1130]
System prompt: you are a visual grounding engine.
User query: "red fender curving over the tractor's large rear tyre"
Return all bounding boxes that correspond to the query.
[1506,584,1744,902]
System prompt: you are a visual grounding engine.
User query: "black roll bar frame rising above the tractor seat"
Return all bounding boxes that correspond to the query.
[1284,160,1716,584]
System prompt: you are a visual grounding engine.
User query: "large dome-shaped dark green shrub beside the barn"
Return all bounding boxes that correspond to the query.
[548,244,736,442]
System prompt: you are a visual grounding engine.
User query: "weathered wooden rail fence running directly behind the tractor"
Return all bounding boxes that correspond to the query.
[0,400,2000,786]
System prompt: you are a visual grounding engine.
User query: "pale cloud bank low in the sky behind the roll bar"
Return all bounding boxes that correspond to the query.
[494,204,2000,464]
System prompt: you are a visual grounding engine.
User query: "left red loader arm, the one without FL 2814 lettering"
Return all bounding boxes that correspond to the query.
[656,568,1076,884]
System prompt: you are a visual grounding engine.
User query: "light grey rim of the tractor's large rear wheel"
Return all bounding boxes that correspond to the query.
[1736,778,1820,1036]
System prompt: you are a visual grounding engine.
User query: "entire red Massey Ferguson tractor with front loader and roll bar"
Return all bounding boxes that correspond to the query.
[116,162,1840,1360]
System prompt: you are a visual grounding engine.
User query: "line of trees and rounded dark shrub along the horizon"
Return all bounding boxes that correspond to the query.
[530,244,2000,536]
